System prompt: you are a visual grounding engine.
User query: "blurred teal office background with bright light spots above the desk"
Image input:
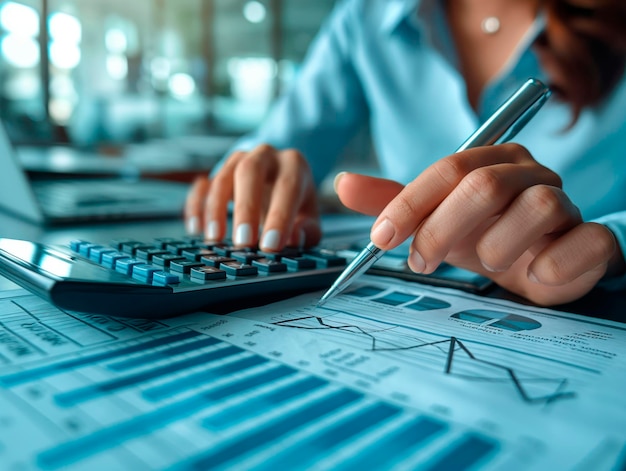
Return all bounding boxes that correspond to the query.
[0,0,335,147]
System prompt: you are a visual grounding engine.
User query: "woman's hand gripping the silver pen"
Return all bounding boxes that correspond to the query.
[335,144,623,305]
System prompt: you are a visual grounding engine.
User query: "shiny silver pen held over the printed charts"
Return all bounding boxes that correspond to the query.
[317,78,551,307]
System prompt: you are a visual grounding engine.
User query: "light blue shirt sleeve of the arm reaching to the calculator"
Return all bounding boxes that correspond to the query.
[213,0,368,184]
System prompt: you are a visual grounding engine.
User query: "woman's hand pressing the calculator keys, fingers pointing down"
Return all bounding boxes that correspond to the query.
[185,145,321,251]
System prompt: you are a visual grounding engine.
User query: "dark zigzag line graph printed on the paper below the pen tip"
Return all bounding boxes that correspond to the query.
[273,315,576,404]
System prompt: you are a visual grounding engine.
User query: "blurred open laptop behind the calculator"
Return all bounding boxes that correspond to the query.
[0,122,188,225]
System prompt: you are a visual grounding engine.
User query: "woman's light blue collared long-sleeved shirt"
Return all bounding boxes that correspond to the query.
[227,0,626,288]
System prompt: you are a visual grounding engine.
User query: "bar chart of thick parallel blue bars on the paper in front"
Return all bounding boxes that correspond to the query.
[0,320,532,470]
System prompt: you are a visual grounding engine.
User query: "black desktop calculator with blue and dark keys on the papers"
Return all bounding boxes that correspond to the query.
[0,237,346,318]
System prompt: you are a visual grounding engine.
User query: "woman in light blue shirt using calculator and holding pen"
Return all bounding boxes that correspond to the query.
[186,0,626,305]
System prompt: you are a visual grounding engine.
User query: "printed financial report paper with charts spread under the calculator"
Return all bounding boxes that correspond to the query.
[0,276,626,470]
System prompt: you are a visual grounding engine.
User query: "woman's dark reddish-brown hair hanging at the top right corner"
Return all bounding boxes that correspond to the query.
[535,0,626,120]
